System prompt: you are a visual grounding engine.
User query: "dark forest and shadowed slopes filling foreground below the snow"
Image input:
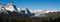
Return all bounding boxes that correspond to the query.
[0,11,60,22]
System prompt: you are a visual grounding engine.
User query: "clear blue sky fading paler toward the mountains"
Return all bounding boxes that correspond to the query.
[0,0,60,10]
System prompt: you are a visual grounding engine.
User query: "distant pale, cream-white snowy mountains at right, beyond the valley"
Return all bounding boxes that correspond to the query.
[30,10,60,16]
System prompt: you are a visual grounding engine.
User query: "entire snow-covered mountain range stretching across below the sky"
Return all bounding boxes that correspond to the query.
[0,3,60,17]
